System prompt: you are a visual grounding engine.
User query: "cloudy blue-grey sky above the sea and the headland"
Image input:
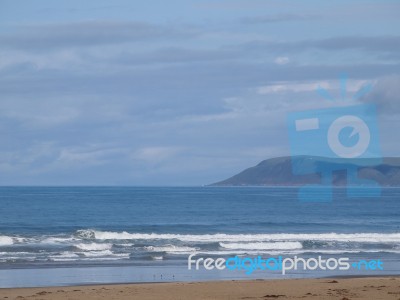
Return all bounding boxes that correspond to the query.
[0,0,400,186]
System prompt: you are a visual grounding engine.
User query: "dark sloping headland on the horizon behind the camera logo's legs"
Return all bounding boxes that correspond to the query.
[210,156,400,186]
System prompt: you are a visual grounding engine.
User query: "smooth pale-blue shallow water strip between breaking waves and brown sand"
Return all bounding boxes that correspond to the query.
[0,262,400,290]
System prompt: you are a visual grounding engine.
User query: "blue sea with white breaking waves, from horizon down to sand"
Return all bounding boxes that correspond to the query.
[0,187,400,287]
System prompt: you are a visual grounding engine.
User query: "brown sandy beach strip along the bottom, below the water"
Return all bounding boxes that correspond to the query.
[0,277,400,300]
